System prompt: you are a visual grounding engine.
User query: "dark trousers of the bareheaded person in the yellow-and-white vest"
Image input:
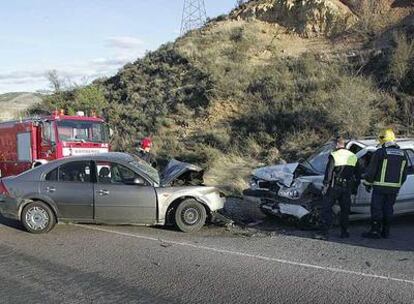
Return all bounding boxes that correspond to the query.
[322,185,352,230]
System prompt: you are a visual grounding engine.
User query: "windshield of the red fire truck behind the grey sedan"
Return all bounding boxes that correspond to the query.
[57,120,109,143]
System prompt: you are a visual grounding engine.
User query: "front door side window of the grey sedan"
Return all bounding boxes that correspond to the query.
[96,162,146,185]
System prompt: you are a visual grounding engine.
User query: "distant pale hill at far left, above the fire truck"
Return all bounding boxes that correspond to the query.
[0,92,42,121]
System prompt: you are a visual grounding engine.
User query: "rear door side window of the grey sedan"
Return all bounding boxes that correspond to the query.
[58,161,91,183]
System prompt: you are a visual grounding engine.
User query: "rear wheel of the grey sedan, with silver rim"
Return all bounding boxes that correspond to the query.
[21,201,56,234]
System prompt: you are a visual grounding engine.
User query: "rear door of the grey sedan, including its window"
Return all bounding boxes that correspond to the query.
[40,161,93,221]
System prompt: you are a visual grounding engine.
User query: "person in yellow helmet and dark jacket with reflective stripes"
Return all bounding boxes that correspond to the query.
[362,129,408,239]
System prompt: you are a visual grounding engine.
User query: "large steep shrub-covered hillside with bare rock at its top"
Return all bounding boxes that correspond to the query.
[35,0,414,188]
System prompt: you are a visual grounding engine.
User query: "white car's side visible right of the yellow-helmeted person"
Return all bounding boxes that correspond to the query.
[394,149,414,213]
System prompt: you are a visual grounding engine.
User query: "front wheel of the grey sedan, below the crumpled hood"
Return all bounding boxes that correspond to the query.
[175,199,207,233]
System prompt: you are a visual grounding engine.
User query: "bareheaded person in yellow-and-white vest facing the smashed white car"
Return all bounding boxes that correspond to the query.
[316,137,361,239]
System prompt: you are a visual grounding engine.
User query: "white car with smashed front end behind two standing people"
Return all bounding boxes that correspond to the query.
[244,139,414,226]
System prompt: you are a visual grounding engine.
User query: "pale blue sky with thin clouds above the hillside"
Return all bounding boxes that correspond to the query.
[0,0,236,93]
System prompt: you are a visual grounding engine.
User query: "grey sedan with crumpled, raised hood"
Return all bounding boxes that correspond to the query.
[0,153,225,233]
